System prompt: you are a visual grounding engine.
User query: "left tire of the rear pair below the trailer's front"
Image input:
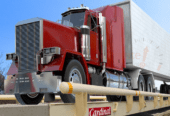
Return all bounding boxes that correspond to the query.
[133,75,146,101]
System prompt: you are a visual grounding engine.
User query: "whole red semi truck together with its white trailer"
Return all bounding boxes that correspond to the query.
[7,1,170,104]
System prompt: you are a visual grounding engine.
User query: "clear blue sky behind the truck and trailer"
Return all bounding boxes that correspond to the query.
[0,0,170,89]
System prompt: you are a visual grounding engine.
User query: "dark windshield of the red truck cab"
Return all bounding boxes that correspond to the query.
[62,12,85,27]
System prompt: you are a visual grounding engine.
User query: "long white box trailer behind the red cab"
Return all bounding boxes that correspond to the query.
[110,0,170,89]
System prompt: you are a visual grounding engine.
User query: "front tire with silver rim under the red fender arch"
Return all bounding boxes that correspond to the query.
[60,60,89,103]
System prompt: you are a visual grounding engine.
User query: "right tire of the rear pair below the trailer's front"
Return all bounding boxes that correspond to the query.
[145,77,153,100]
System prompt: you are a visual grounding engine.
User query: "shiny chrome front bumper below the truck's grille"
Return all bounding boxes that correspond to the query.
[14,72,62,94]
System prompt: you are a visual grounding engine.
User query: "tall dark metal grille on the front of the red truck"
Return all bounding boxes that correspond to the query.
[16,21,40,72]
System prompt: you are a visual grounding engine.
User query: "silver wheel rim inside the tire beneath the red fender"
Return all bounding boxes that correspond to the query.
[69,68,82,97]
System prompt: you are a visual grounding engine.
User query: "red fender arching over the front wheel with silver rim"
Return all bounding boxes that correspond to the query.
[59,50,91,84]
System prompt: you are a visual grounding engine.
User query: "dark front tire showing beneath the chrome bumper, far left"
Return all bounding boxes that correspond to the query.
[15,93,44,105]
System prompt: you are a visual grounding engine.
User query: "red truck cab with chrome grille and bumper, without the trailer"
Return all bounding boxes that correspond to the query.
[7,5,130,104]
